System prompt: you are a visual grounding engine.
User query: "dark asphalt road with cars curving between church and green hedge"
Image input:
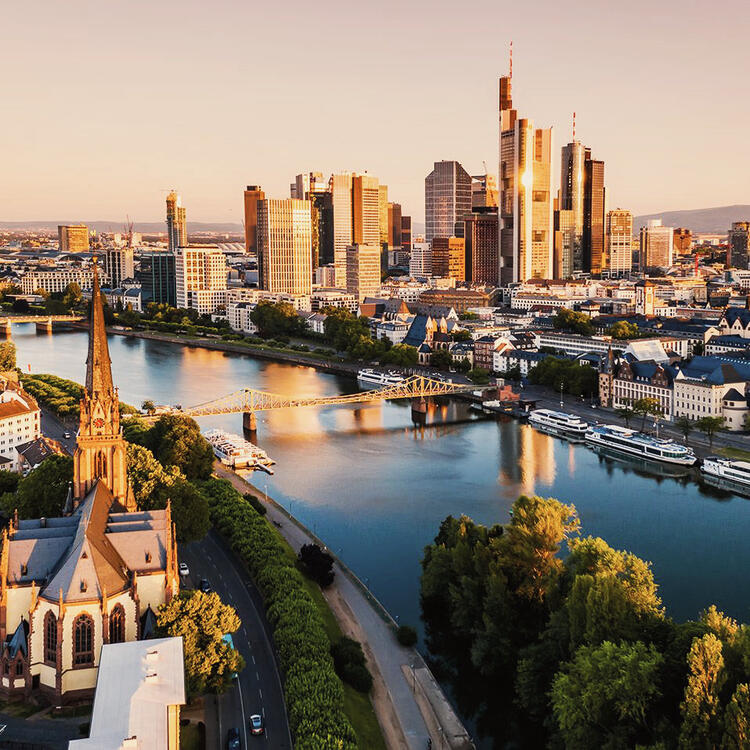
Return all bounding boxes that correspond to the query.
[179,532,292,750]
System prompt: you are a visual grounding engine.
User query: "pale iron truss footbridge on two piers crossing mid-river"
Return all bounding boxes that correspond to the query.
[179,375,476,432]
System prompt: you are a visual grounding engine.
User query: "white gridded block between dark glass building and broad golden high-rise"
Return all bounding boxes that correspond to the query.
[175,245,227,315]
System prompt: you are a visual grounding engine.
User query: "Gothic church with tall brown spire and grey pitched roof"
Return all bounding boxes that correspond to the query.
[0,266,179,703]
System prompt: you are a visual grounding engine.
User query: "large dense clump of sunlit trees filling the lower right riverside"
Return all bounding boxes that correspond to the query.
[421,497,750,750]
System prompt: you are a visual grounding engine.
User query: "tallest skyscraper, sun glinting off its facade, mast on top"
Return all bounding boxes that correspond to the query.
[498,76,553,284]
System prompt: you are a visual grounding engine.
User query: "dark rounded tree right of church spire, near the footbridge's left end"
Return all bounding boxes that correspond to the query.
[146,414,214,479]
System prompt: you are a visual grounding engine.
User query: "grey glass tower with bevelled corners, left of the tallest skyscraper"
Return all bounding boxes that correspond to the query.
[424,161,471,242]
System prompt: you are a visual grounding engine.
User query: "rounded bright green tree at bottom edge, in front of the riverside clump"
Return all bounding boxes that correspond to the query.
[551,641,664,750]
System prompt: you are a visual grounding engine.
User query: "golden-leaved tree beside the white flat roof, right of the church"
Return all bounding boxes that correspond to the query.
[156,591,245,696]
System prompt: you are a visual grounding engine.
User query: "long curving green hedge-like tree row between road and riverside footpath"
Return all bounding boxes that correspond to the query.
[202,478,357,750]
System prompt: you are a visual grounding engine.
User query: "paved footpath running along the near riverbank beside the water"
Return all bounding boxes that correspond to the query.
[215,463,473,750]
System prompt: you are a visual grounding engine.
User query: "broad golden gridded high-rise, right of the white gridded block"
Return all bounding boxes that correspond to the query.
[258,198,313,294]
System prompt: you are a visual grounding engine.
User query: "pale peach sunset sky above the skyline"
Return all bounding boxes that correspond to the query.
[0,0,750,222]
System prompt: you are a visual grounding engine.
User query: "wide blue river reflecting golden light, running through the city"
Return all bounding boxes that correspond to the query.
[13,325,750,626]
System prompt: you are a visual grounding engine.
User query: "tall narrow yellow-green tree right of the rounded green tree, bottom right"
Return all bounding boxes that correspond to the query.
[680,633,726,750]
